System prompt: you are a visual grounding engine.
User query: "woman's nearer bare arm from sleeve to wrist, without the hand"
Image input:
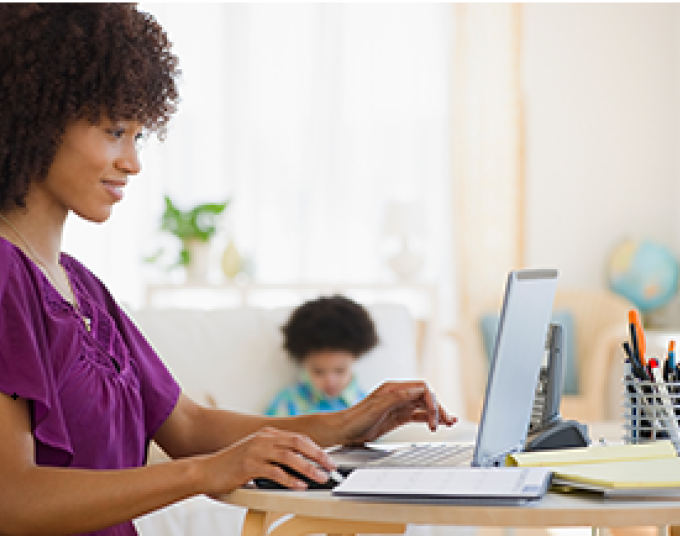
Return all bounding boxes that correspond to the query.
[0,393,205,535]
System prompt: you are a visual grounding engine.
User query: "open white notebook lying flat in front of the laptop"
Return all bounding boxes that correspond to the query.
[333,467,550,505]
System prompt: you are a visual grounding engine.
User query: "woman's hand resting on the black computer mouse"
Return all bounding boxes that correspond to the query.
[201,427,336,495]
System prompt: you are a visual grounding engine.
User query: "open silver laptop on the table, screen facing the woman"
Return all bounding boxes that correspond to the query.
[329,269,557,475]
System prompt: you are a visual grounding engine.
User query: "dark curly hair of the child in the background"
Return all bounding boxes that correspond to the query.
[281,296,378,362]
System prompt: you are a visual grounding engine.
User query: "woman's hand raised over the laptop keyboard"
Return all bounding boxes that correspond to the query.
[340,381,458,445]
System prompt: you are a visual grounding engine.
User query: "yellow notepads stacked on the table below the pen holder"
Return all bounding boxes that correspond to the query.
[507,441,680,499]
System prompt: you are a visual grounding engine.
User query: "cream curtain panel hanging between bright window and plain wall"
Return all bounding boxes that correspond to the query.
[453,4,525,317]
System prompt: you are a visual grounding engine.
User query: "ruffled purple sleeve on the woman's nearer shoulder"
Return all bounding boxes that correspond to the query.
[0,249,73,466]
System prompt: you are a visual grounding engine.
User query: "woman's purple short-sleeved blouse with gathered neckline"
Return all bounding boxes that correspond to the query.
[0,238,180,536]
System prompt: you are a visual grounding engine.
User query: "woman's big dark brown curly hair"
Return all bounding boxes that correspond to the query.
[0,3,180,211]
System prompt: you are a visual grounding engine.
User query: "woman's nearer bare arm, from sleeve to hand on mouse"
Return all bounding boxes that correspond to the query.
[0,393,338,536]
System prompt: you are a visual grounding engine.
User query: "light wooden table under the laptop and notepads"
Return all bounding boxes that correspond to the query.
[222,489,680,536]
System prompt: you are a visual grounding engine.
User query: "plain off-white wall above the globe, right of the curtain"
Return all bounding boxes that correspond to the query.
[524,4,680,288]
